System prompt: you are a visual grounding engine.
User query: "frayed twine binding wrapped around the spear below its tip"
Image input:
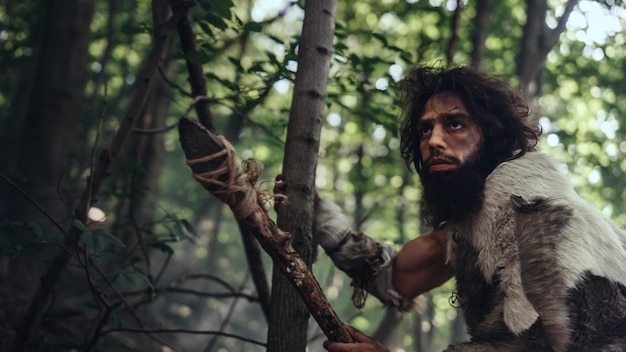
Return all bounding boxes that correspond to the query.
[187,136,267,220]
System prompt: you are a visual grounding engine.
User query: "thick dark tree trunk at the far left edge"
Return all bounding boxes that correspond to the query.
[0,0,94,346]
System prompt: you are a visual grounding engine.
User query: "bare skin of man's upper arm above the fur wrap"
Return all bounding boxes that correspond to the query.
[393,230,453,299]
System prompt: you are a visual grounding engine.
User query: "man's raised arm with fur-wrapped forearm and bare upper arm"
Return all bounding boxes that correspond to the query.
[314,197,452,310]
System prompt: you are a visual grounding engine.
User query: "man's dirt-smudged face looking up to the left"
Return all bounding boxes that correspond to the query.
[417,92,482,174]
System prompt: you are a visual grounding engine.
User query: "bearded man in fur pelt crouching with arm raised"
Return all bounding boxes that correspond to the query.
[315,67,626,352]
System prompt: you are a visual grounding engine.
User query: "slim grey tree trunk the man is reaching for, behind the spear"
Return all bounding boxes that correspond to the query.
[267,0,337,352]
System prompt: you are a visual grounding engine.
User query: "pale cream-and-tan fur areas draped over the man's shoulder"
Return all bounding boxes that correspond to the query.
[448,152,626,334]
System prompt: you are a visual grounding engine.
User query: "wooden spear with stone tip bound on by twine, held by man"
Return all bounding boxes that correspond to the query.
[178,118,352,342]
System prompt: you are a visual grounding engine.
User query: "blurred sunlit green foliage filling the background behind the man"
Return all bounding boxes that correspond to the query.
[0,0,626,351]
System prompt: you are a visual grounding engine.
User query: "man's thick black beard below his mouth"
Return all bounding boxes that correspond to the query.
[420,148,495,227]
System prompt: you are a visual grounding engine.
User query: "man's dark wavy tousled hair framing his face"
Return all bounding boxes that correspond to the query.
[400,66,541,174]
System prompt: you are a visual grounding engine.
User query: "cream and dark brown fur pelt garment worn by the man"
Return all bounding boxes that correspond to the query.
[446,152,626,352]
